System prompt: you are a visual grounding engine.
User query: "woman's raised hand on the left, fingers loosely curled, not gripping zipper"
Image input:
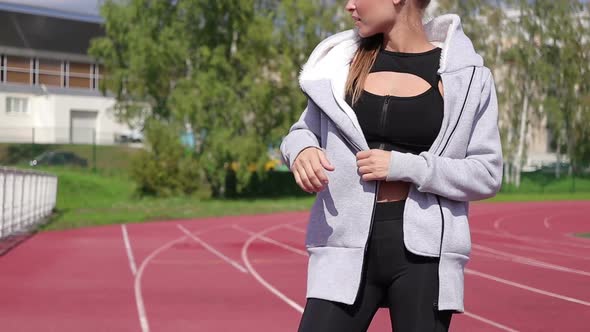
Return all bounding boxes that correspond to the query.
[291,147,335,193]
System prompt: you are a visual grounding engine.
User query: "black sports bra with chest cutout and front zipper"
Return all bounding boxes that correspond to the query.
[346,47,443,154]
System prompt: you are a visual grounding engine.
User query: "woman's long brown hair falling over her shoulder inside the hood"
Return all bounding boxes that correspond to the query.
[345,0,430,105]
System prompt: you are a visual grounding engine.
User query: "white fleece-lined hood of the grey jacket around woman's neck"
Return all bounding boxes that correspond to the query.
[299,14,483,91]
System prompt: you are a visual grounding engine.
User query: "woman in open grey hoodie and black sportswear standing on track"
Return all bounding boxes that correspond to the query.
[280,0,503,332]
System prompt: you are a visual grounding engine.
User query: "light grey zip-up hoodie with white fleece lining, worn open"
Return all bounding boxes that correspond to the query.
[280,14,503,313]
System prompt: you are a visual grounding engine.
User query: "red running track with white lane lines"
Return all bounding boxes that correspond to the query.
[0,201,590,332]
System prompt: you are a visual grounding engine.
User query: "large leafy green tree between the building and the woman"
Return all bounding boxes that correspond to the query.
[90,0,342,197]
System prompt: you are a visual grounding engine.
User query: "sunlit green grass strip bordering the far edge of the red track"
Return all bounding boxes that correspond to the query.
[27,168,590,231]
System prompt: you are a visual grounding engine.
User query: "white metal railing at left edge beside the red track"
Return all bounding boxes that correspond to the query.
[0,166,57,240]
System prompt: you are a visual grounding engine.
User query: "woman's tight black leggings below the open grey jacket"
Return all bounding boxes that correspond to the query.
[298,200,454,332]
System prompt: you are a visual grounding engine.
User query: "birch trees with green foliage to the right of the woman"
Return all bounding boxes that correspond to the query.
[439,0,590,179]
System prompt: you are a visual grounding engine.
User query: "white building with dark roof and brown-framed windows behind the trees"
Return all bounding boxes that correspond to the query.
[0,3,131,144]
